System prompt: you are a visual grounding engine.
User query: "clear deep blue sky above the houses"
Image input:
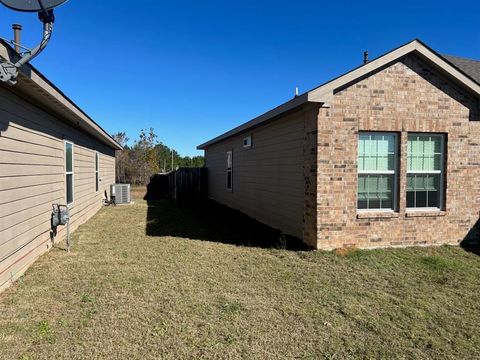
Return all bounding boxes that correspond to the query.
[0,0,480,155]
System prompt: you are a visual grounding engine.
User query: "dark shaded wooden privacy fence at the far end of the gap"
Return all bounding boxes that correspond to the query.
[145,168,207,200]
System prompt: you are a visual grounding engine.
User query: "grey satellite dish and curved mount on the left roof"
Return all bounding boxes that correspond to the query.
[0,0,67,85]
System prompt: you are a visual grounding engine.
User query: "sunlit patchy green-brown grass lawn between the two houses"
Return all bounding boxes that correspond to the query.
[0,190,480,360]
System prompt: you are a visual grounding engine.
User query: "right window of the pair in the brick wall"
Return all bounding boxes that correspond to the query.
[407,134,444,209]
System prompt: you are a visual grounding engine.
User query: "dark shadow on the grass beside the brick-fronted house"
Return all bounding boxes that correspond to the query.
[146,200,308,250]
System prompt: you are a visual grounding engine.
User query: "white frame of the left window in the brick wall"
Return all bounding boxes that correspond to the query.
[356,131,401,213]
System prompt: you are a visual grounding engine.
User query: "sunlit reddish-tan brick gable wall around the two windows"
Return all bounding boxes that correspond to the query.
[312,56,480,249]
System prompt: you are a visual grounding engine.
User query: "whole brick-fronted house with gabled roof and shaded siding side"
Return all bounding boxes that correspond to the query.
[198,40,480,249]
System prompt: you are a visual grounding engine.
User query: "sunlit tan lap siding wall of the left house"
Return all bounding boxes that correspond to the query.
[0,88,115,292]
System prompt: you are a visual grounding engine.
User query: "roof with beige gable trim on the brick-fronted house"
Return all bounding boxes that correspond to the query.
[197,39,480,150]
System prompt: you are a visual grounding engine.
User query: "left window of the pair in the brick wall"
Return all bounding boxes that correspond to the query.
[357,133,398,210]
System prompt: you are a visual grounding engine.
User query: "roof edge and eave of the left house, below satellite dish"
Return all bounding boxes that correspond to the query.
[0,40,123,150]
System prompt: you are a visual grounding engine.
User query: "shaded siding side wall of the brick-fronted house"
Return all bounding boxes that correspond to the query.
[205,112,305,238]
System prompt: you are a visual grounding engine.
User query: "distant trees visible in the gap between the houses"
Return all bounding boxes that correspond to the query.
[112,128,204,185]
